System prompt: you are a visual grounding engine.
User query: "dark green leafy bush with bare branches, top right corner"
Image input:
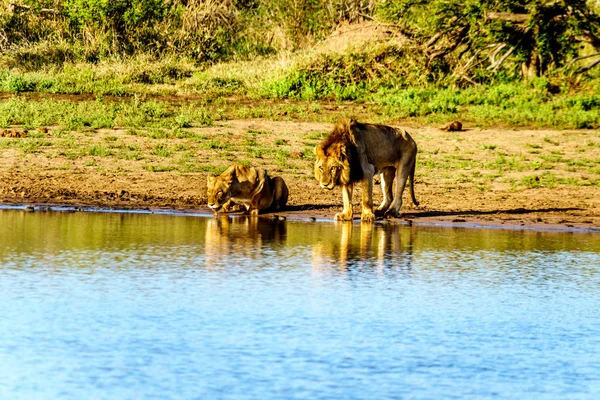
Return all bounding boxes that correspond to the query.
[379,0,600,82]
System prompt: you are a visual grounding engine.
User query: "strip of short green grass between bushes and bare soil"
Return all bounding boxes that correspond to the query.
[0,72,600,128]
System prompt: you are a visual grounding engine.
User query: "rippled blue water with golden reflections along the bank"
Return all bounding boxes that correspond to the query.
[0,210,600,399]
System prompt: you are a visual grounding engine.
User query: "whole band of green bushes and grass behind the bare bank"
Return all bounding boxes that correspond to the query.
[0,0,600,128]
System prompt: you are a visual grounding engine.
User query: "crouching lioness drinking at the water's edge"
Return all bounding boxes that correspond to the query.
[206,164,289,215]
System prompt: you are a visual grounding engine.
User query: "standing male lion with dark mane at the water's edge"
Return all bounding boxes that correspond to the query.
[315,119,419,222]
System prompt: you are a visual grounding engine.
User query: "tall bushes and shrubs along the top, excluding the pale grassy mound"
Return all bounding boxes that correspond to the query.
[0,0,600,88]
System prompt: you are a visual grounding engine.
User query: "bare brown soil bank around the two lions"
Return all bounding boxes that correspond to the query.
[0,120,600,231]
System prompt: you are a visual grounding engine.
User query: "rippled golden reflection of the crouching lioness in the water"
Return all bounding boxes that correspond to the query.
[205,214,286,267]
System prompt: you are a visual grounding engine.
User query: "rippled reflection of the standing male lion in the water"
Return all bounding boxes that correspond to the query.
[312,222,412,273]
